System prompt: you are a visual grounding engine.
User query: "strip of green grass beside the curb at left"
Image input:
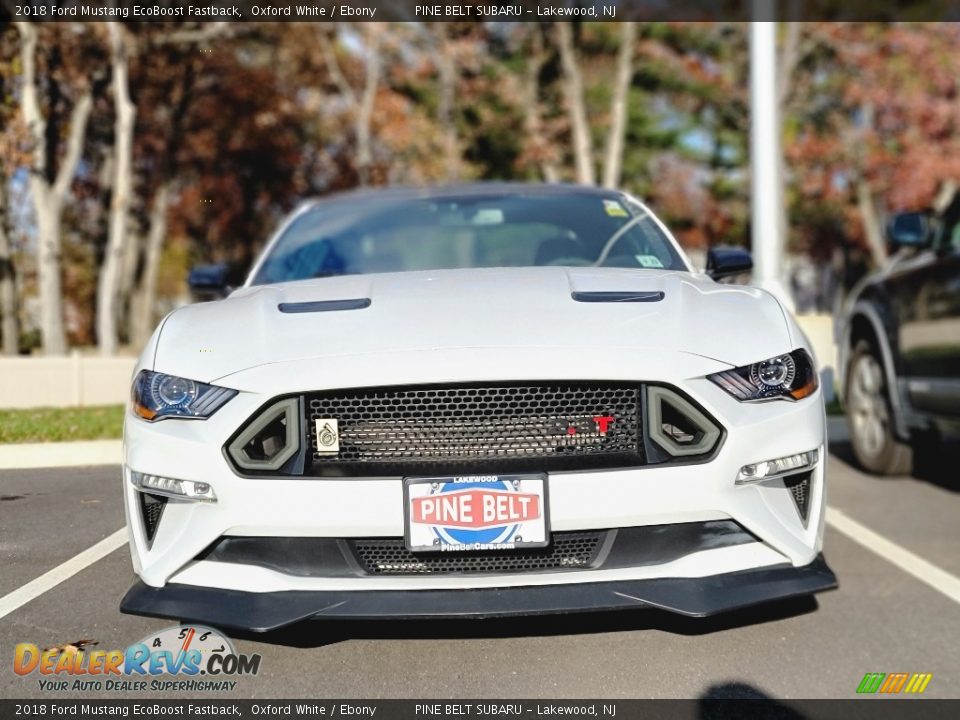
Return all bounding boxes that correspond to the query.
[0,405,123,443]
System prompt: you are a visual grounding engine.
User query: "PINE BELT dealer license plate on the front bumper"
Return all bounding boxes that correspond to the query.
[403,473,550,552]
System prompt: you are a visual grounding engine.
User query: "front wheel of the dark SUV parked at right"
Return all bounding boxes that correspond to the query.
[845,340,912,475]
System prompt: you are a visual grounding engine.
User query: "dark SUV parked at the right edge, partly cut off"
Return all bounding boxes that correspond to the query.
[837,200,960,475]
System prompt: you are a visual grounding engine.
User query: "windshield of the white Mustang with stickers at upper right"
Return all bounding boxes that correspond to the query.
[252,192,687,285]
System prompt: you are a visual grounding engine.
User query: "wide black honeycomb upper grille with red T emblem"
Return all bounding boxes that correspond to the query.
[304,382,644,475]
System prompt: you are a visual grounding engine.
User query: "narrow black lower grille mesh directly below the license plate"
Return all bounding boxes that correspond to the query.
[349,531,607,575]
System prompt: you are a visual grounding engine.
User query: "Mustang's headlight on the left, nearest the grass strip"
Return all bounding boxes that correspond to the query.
[131,370,237,421]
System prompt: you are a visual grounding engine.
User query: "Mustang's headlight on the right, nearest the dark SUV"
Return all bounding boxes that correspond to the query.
[707,349,819,402]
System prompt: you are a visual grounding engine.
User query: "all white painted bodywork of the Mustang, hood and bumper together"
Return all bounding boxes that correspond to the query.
[118,190,826,612]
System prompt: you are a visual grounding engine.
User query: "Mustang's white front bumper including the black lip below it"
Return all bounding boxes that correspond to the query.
[123,354,835,630]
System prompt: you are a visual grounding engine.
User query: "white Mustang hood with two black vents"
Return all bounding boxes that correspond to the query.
[154,267,795,382]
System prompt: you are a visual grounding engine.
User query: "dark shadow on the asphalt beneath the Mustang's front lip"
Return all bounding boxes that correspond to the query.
[231,596,818,648]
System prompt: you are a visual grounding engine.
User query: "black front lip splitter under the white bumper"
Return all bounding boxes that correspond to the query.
[120,555,837,632]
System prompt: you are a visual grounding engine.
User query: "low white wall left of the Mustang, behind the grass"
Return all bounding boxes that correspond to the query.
[0,354,137,409]
